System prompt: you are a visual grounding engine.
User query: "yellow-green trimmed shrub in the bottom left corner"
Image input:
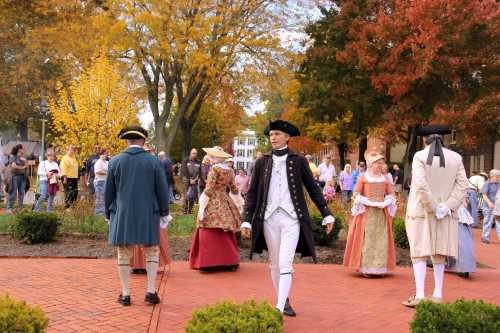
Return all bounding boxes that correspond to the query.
[0,295,49,333]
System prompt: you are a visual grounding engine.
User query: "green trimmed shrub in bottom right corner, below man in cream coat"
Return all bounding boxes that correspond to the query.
[410,299,500,333]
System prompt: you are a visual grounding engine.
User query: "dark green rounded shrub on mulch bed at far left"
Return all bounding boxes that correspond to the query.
[10,212,60,244]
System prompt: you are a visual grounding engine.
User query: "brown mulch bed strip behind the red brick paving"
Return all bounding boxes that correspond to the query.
[0,235,411,266]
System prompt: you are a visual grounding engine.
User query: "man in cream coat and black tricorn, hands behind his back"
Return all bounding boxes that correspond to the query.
[403,125,468,307]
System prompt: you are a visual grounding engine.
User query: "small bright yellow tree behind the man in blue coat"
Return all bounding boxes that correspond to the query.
[49,56,138,156]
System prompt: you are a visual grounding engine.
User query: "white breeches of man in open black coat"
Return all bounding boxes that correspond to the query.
[264,208,300,274]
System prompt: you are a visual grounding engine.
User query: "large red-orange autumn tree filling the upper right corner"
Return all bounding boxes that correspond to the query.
[340,0,500,165]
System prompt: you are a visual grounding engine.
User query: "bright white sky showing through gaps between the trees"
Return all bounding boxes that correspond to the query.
[139,0,323,128]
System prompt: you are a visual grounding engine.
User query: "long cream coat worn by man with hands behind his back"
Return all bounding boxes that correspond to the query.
[406,147,468,258]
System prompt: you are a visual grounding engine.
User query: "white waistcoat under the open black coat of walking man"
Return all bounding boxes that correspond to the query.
[264,154,297,219]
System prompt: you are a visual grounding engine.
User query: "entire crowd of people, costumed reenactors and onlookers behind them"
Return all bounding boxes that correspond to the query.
[2,120,500,316]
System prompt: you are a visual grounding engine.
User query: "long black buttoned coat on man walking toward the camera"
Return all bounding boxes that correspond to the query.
[242,151,331,262]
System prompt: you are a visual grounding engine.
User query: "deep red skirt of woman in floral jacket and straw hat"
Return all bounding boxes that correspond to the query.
[189,228,240,269]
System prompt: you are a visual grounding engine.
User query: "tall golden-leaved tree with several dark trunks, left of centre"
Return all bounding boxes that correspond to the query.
[96,0,287,153]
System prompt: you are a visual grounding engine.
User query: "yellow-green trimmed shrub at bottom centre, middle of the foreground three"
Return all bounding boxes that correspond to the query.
[186,300,283,333]
